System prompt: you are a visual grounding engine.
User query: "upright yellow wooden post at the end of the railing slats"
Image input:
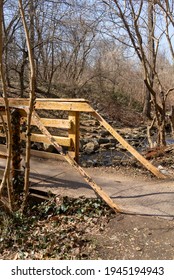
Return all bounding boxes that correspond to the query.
[68,111,79,162]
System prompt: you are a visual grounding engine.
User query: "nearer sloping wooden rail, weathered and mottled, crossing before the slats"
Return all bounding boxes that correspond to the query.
[30,111,121,212]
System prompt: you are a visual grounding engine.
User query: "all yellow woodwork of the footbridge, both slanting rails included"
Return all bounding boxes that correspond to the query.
[0,98,165,212]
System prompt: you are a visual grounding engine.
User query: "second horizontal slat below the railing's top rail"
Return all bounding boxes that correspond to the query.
[21,133,71,147]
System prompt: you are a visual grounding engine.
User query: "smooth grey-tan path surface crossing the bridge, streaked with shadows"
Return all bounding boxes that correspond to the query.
[0,157,174,218]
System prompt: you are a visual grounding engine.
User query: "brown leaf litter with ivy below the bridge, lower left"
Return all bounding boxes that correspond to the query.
[0,196,115,260]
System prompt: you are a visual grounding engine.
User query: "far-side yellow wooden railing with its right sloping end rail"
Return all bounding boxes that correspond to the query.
[0,98,165,178]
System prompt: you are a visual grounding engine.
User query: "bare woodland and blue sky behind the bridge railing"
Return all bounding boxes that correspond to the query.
[3,0,174,129]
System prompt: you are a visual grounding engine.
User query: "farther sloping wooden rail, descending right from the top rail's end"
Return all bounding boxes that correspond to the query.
[92,112,166,179]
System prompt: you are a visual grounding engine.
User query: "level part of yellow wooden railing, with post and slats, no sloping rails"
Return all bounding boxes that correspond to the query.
[0,98,94,162]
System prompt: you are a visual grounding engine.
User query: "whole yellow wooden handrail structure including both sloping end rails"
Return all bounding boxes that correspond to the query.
[0,98,166,212]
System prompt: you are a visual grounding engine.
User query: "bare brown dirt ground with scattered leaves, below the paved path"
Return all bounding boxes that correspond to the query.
[91,214,174,260]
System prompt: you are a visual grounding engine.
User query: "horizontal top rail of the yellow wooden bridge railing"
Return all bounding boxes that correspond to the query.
[0,98,94,112]
